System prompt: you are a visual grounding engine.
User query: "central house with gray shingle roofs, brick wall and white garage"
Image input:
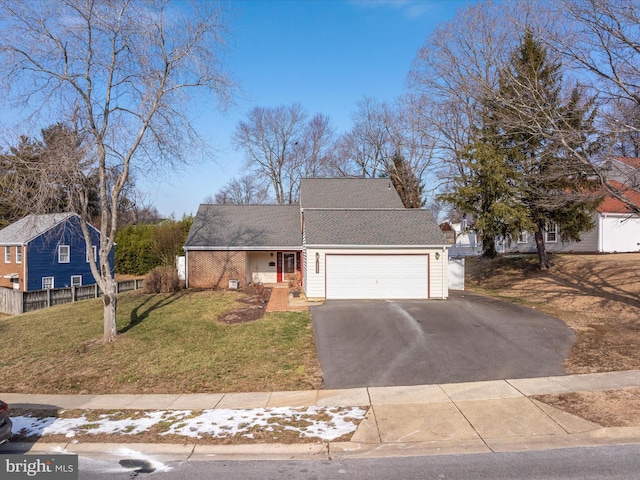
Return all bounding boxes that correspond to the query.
[184,178,448,299]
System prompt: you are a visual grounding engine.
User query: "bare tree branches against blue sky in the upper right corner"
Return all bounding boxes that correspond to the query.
[543,0,640,214]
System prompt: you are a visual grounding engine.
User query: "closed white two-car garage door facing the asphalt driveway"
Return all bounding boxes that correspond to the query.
[326,254,429,298]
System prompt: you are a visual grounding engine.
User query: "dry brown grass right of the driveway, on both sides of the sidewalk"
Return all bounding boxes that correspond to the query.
[466,253,640,427]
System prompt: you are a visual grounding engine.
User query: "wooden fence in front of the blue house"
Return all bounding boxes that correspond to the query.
[0,279,144,315]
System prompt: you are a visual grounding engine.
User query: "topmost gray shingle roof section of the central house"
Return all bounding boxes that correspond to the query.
[300,178,403,209]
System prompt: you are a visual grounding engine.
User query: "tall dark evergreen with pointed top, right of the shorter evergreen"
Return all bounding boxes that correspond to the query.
[490,30,600,268]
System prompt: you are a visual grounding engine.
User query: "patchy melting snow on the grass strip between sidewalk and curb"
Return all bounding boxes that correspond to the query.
[12,407,366,441]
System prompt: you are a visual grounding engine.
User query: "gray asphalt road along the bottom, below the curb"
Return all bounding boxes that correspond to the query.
[78,445,640,480]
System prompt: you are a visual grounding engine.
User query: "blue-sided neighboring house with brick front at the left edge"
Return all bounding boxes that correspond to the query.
[0,213,114,291]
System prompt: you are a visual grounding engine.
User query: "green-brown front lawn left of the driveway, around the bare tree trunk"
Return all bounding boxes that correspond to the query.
[0,291,320,394]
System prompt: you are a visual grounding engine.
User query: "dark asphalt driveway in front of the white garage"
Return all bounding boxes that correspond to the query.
[311,292,575,389]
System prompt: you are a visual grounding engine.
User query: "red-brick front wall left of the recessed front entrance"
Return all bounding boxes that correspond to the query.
[187,250,247,288]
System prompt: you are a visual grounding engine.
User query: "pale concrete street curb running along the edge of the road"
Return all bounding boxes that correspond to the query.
[0,427,640,462]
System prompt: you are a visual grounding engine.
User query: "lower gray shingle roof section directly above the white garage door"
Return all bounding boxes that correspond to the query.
[304,209,447,246]
